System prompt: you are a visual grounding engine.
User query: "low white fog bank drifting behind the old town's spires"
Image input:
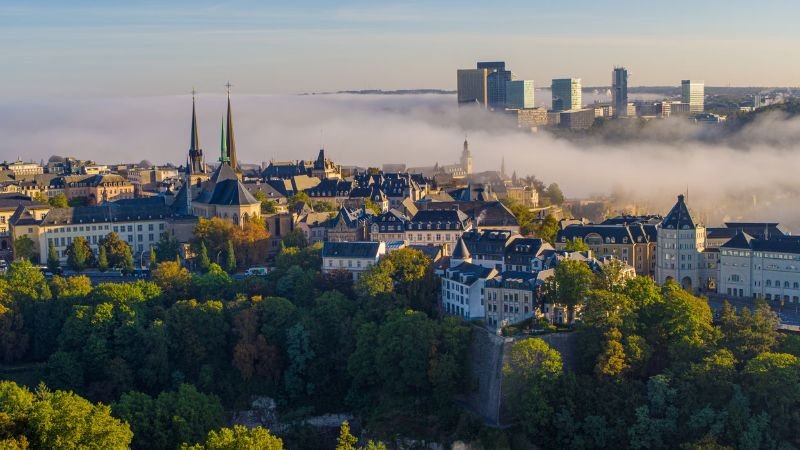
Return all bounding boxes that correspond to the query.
[0,91,800,230]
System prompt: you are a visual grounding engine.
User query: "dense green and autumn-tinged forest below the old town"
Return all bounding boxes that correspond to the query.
[0,232,800,449]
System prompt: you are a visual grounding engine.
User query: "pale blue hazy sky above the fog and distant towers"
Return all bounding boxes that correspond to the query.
[0,0,800,98]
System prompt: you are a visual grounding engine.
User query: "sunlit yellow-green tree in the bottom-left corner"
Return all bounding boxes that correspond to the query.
[0,381,133,449]
